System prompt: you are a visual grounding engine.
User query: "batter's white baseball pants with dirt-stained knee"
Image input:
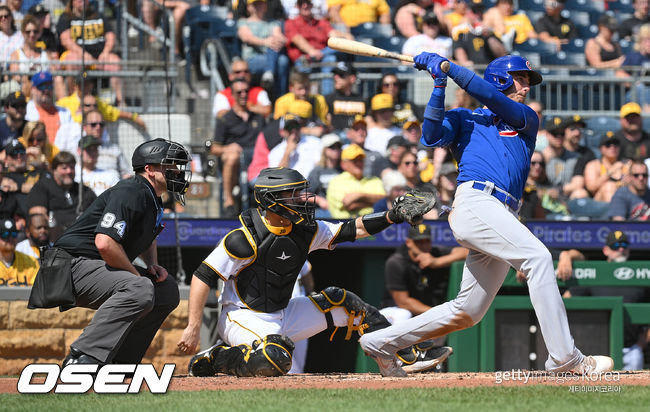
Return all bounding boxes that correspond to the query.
[360,182,583,372]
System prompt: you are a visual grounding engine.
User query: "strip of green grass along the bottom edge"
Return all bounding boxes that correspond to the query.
[0,385,650,412]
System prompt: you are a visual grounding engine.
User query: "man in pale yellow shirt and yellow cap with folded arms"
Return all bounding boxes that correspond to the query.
[327,144,386,219]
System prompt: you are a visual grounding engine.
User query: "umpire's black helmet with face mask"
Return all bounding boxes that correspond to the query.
[131,139,192,205]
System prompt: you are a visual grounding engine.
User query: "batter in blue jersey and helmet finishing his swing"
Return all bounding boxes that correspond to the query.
[360,53,613,373]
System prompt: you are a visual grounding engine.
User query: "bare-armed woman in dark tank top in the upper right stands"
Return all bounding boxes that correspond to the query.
[585,14,625,69]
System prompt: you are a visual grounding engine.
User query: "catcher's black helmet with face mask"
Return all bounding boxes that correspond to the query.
[253,167,316,225]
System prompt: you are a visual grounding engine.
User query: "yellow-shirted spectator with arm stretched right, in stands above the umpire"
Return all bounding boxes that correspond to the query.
[56,73,146,129]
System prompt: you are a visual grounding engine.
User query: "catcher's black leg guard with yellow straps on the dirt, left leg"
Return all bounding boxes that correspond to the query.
[213,335,295,376]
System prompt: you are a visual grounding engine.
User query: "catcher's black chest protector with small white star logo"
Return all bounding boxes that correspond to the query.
[235,209,316,313]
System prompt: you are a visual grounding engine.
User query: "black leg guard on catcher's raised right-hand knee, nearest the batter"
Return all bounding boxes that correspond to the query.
[309,286,390,340]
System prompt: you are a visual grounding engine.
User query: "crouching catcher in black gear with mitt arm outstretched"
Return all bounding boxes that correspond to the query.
[178,168,435,376]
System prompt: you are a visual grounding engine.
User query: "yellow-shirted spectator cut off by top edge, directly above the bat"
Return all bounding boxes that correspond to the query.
[327,0,390,29]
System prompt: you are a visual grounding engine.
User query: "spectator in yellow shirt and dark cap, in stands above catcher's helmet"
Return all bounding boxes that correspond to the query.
[273,72,329,137]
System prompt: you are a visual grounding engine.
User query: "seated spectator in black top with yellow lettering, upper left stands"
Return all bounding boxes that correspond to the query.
[56,0,124,106]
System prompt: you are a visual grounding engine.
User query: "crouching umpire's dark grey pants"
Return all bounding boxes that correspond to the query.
[70,257,180,364]
